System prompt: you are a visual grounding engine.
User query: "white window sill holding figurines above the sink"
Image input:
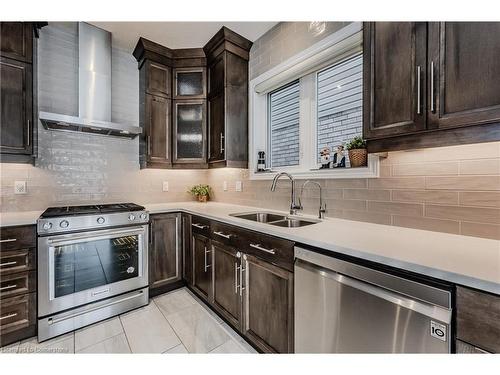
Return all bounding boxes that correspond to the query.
[249,155,380,180]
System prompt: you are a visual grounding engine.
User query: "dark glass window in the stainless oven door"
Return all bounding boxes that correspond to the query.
[54,235,139,298]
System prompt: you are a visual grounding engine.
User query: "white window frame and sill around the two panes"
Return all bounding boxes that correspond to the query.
[249,22,379,180]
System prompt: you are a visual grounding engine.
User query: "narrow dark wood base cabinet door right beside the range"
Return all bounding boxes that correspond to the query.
[149,214,182,295]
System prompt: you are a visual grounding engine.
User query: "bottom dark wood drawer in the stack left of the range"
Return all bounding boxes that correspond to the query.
[0,293,36,334]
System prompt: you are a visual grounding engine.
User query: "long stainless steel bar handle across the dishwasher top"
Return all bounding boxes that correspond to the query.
[295,259,452,324]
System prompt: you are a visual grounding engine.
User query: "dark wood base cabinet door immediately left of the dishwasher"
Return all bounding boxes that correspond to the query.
[243,255,293,353]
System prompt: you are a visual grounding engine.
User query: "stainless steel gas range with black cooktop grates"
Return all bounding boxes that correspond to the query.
[37,203,149,341]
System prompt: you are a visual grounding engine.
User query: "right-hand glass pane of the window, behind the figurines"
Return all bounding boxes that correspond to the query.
[317,54,363,160]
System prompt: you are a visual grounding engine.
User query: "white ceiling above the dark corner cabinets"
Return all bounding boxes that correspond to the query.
[90,22,277,52]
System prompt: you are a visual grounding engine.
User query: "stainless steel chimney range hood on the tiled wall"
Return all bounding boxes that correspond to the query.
[39,22,142,138]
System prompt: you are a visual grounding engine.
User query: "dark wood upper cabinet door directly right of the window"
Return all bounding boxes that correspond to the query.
[363,22,427,139]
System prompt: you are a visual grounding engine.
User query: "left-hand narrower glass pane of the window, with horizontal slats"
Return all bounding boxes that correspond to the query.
[269,80,300,167]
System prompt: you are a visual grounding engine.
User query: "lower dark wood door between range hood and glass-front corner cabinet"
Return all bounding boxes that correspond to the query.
[146,95,171,164]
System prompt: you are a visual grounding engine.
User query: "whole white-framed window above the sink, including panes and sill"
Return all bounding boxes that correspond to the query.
[250,23,378,179]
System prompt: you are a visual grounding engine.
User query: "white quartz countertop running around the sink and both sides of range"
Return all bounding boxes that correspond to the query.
[0,202,500,294]
